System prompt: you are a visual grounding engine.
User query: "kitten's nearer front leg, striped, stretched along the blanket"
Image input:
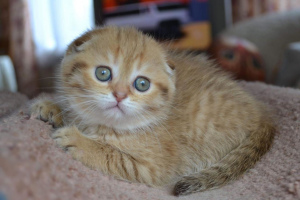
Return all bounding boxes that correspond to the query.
[52,126,156,185]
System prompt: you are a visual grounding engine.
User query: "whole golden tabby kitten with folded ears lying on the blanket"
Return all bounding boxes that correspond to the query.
[32,27,275,195]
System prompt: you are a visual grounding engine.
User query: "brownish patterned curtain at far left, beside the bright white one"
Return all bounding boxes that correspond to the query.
[0,0,38,97]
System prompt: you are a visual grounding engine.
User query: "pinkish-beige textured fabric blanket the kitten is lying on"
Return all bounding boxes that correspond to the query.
[0,82,300,200]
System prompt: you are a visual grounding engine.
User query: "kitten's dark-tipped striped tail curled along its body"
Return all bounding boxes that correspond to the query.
[174,119,275,196]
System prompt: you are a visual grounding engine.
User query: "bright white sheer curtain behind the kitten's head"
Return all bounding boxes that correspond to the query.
[28,0,94,68]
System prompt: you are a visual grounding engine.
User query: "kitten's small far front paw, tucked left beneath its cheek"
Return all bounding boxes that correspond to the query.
[31,100,63,128]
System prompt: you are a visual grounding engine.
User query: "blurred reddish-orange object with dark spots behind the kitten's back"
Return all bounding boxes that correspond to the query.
[210,37,265,81]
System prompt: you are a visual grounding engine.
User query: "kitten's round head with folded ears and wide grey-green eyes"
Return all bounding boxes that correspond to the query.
[60,27,175,130]
